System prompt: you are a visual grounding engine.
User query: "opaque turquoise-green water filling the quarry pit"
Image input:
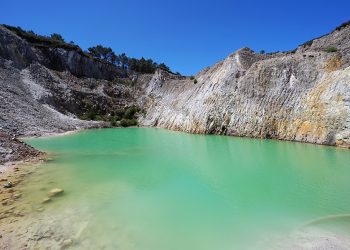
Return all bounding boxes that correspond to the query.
[22,128,350,250]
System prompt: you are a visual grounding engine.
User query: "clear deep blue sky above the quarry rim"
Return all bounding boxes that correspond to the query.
[0,0,350,75]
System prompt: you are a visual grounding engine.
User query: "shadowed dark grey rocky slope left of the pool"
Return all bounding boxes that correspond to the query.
[0,25,150,161]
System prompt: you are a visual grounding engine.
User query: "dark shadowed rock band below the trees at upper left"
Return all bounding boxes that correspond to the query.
[0,25,126,81]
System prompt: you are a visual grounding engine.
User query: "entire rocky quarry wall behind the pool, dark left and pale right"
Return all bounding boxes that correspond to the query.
[0,22,350,150]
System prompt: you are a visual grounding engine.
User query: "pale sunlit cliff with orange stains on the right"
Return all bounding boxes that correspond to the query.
[142,25,350,147]
